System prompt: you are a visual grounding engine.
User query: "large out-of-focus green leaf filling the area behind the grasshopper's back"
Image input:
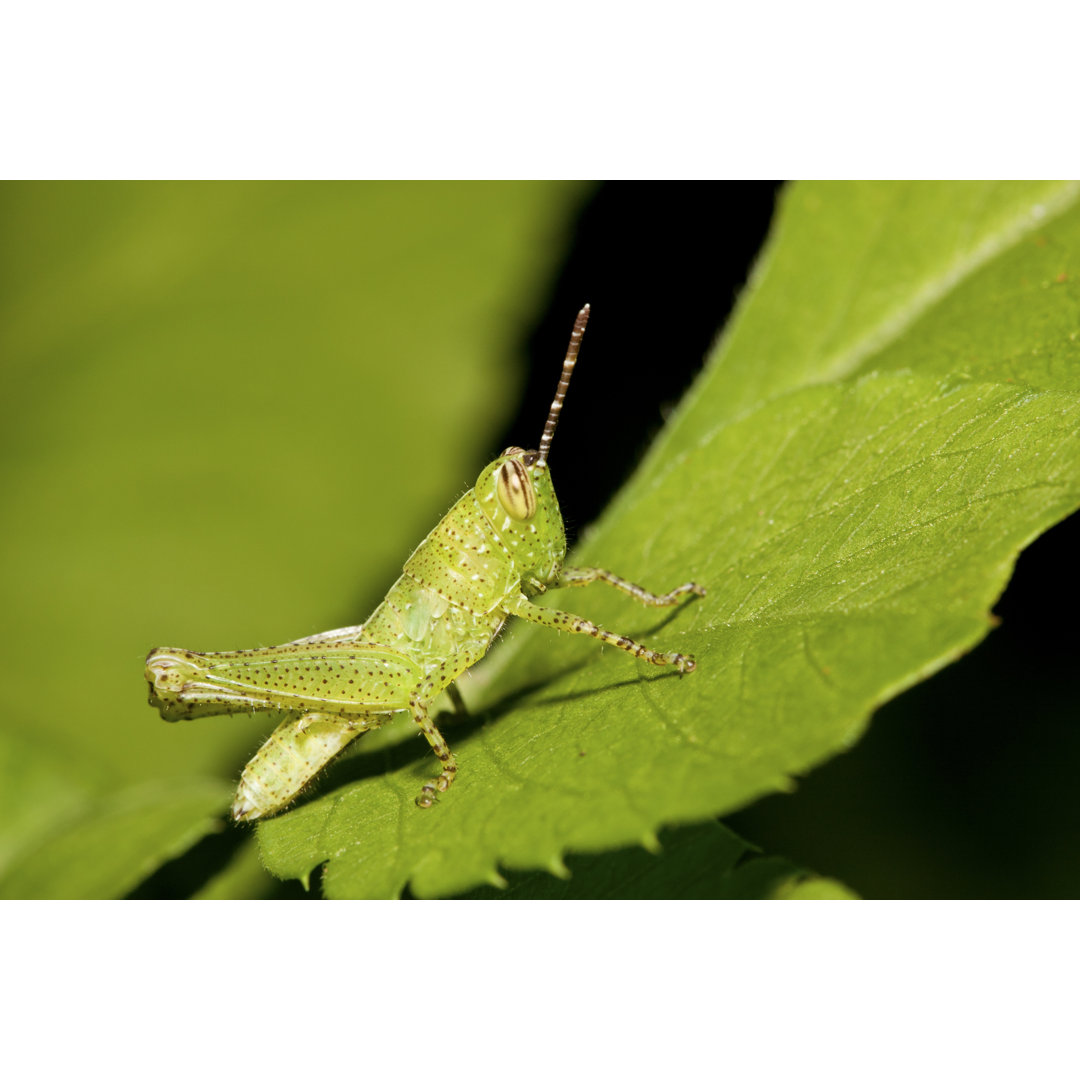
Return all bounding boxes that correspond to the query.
[0,184,583,818]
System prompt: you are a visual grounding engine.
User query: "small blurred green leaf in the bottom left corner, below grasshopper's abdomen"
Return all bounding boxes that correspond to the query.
[0,779,232,900]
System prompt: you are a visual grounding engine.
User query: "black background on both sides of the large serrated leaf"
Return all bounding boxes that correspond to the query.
[501,184,1080,897]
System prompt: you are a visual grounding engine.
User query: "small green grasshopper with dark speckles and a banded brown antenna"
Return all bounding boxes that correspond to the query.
[146,303,705,821]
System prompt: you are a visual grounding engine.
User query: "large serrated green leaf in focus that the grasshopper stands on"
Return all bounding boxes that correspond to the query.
[259,184,1080,896]
